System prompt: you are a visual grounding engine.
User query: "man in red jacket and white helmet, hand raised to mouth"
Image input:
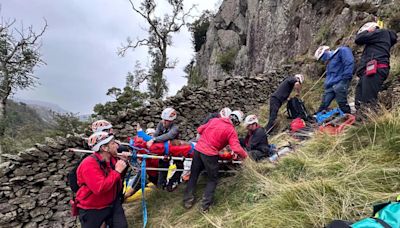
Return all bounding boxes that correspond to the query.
[76,132,128,228]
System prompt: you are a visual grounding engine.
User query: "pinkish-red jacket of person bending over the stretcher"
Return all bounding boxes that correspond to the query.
[195,118,247,158]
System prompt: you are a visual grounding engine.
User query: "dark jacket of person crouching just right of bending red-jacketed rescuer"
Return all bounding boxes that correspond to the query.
[244,127,269,153]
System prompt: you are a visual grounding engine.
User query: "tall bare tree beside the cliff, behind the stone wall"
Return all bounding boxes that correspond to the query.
[119,0,195,99]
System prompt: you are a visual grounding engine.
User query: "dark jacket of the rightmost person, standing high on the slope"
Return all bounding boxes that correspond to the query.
[355,29,397,76]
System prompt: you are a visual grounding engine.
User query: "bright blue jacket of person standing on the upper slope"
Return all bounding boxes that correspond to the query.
[325,47,354,89]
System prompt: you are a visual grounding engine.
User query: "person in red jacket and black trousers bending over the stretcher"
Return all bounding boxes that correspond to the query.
[183,111,247,212]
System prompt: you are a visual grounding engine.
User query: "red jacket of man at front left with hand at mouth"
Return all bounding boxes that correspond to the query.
[76,153,122,209]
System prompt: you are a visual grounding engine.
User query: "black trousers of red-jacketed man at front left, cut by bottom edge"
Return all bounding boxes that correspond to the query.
[79,200,128,228]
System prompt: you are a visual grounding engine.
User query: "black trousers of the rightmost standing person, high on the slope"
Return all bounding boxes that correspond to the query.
[355,68,390,110]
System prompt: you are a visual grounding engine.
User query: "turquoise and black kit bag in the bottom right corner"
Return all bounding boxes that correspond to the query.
[326,198,400,228]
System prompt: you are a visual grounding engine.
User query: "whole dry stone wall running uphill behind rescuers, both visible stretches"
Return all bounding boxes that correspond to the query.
[0,71,288,227]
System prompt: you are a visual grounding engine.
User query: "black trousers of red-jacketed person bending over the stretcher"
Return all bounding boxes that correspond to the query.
[183,150,219,208]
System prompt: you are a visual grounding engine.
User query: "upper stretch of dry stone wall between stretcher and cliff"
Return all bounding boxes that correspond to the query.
[107,71,287,140]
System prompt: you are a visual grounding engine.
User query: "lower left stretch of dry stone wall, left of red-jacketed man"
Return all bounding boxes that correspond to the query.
[0,136,83,227]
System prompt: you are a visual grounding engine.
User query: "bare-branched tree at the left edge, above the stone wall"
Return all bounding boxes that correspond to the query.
[0,18,47,162]
